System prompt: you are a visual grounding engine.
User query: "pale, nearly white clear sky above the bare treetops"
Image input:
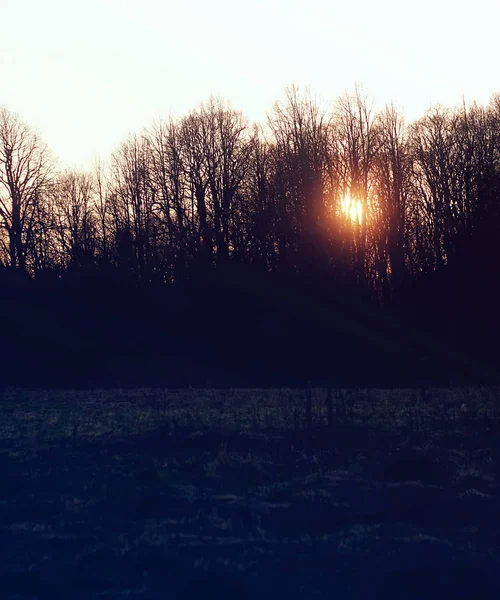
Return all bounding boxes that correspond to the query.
[0,0,500,168]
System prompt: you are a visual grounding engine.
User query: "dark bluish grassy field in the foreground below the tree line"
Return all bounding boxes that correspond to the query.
[0,388,500,600]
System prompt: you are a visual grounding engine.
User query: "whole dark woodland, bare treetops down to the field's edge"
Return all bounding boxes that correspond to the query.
[0,87,500,387]
